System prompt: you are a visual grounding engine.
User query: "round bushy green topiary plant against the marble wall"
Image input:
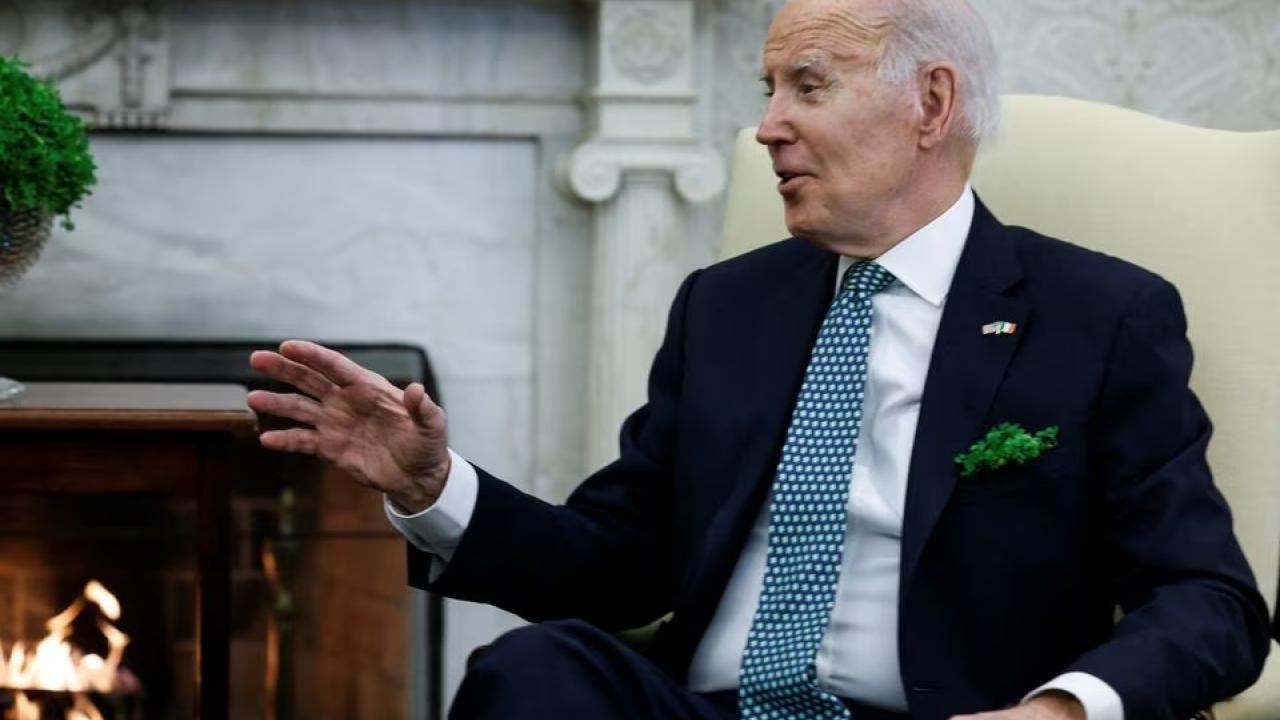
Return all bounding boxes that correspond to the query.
[0,56,96,229]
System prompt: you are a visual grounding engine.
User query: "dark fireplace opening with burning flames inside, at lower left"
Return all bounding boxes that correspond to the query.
[0,495,199,720]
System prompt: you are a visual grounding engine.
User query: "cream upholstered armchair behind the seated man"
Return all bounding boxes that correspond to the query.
[722,95,1280,720]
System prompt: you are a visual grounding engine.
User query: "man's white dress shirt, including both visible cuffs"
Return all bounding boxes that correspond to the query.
[387,187,1124,720]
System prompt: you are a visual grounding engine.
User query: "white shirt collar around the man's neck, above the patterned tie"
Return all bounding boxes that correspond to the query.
[836,183,974,307]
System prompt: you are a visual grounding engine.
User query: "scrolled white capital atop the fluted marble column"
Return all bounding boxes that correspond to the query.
[561,140,724,202]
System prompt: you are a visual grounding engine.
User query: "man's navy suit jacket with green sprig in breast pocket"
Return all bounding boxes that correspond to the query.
[410,197,1268,720]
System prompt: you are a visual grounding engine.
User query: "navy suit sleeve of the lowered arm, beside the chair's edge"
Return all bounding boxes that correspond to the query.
[1070,275,1268,720]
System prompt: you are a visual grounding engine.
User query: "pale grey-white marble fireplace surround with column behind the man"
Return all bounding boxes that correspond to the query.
[0,0,723,717]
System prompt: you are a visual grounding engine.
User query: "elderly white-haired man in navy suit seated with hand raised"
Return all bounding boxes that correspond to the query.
[251,0,1267,720]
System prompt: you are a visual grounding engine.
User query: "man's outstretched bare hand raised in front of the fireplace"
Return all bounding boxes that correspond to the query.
[248,340,449,512]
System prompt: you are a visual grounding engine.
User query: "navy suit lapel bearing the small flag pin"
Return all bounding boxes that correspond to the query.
[900,201,1029,589]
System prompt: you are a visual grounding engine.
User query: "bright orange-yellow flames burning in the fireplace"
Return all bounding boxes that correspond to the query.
[0,580,129,720]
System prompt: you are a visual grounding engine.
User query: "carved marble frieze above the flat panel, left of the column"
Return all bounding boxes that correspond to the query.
[0,0,593,138]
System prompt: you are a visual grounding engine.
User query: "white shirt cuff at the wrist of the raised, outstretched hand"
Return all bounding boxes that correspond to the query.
[383,450,480,563]
